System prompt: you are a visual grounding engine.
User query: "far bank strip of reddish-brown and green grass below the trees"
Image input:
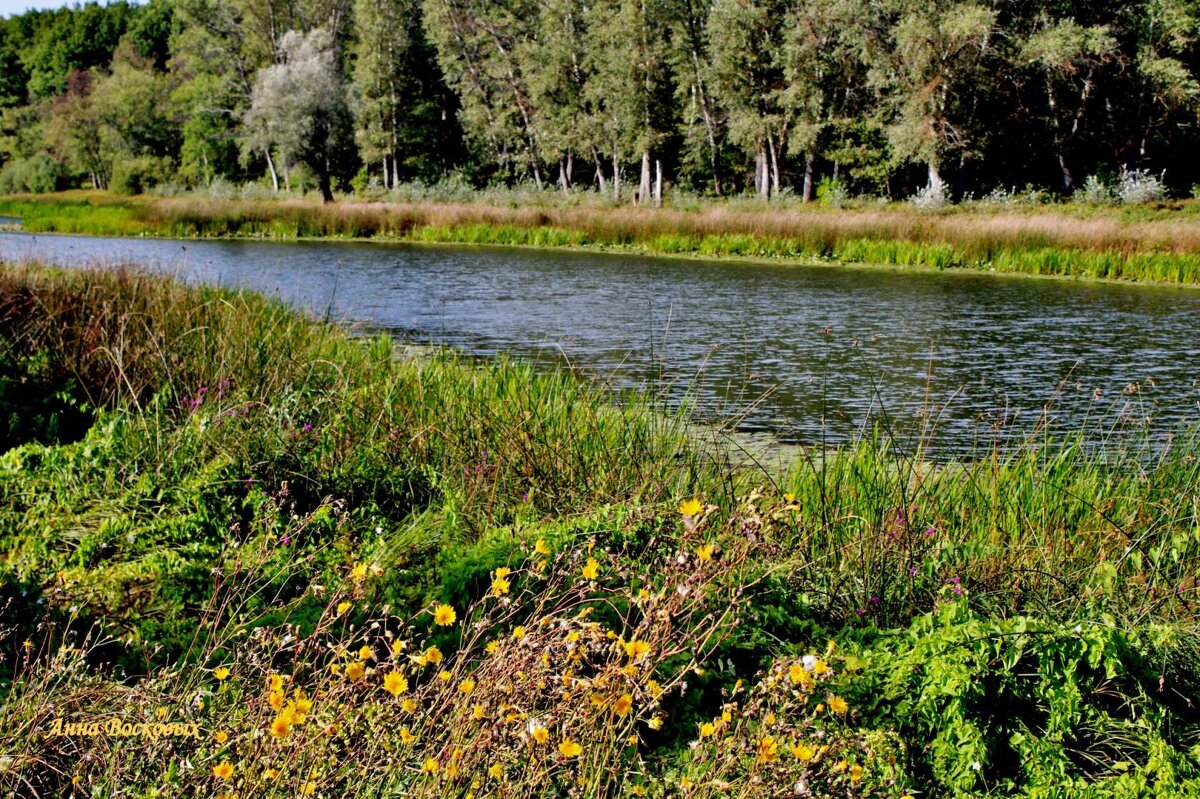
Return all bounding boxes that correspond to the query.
[11,192,1200,284]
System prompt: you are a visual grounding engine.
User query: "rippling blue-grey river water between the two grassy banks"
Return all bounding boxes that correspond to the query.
[0,233,1200,456]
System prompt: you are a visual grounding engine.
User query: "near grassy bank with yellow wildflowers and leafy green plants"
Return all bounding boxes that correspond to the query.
[0,266,1200,798]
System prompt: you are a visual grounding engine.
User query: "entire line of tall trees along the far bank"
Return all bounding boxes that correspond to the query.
[0,0,1200,202]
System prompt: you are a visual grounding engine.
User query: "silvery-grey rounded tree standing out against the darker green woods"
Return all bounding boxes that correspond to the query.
[244,29,350,203]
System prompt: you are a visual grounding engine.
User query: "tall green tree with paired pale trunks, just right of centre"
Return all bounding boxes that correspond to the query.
[708,0,791,198]
